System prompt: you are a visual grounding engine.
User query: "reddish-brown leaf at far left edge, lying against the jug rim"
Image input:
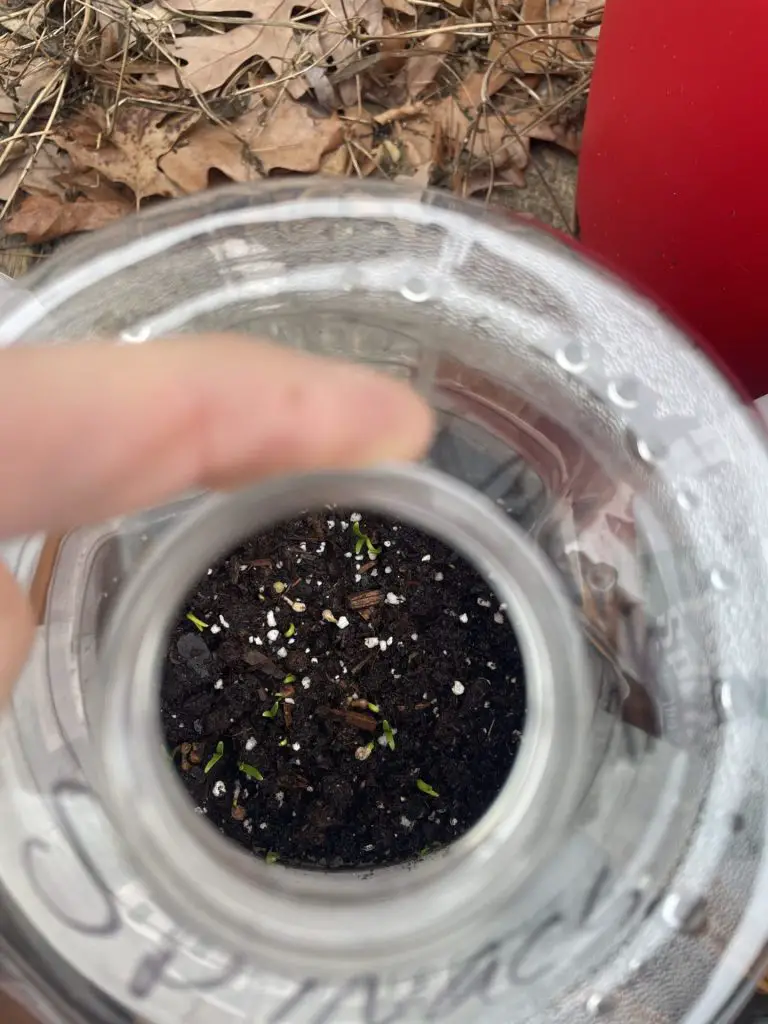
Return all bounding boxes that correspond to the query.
[3,194,133,243]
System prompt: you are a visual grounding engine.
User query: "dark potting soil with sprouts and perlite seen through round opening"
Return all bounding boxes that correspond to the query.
[162,511,525,868]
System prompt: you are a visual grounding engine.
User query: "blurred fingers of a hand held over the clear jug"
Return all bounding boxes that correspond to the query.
[0,338,432,702]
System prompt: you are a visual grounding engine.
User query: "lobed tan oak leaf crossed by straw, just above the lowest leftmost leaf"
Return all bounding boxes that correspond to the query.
[53,105,200,202]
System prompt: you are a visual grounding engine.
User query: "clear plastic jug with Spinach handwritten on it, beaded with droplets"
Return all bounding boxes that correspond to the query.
[0,180,768,1024]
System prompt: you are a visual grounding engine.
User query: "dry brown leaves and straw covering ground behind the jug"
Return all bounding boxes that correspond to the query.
[0,0,602,243]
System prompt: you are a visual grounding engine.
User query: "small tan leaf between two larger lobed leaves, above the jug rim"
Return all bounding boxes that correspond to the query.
[159,118,261,195]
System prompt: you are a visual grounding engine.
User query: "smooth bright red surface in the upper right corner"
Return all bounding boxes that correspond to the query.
[578,0,768,396]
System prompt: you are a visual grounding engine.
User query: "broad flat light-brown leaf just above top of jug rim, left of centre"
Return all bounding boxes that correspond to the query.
[231,96,344,174]
